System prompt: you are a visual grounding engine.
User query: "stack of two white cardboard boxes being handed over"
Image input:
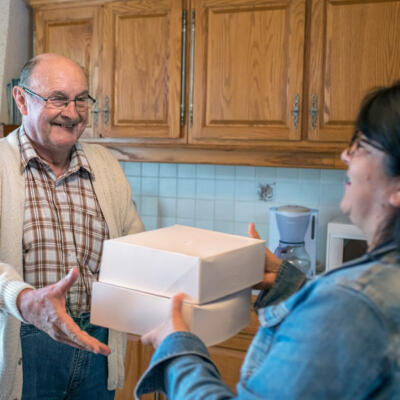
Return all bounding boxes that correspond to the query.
[91,225,265,346]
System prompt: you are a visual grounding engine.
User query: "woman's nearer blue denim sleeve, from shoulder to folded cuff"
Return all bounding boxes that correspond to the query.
[136,285,389,400]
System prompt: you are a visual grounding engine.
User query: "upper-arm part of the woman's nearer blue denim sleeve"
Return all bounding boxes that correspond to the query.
[238,285,390,400]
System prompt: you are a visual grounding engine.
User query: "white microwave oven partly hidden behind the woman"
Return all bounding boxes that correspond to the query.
[325,215,367,271]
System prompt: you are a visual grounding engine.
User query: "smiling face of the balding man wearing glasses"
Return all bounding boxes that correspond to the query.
[19,57,88,153]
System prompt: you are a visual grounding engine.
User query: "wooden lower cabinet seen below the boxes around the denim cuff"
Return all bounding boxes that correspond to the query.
[115,304,258,400]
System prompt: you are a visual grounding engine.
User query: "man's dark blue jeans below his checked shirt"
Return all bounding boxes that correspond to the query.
[21,317,115,400]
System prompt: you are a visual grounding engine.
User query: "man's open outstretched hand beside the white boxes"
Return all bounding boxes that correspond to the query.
[17,268,111,356]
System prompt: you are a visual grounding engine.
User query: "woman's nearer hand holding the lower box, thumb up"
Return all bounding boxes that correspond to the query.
[140,293,189,348]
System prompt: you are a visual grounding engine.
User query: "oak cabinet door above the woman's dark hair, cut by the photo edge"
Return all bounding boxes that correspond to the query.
[307,0,400,142]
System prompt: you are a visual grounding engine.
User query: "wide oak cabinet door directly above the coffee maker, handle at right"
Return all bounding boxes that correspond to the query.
[189,0,305,144]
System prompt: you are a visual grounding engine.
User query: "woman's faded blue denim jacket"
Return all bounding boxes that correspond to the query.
[135,244,400,400]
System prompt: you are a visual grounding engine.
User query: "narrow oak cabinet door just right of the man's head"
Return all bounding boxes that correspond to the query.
[102,0,185,143]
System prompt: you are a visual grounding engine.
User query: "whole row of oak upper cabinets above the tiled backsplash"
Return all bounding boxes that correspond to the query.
[31,0,400,168]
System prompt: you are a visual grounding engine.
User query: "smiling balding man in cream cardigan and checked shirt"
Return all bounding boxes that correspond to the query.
[0,54,143,400]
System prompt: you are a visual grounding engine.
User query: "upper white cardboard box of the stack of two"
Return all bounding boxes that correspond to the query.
[99,225,265,304]
